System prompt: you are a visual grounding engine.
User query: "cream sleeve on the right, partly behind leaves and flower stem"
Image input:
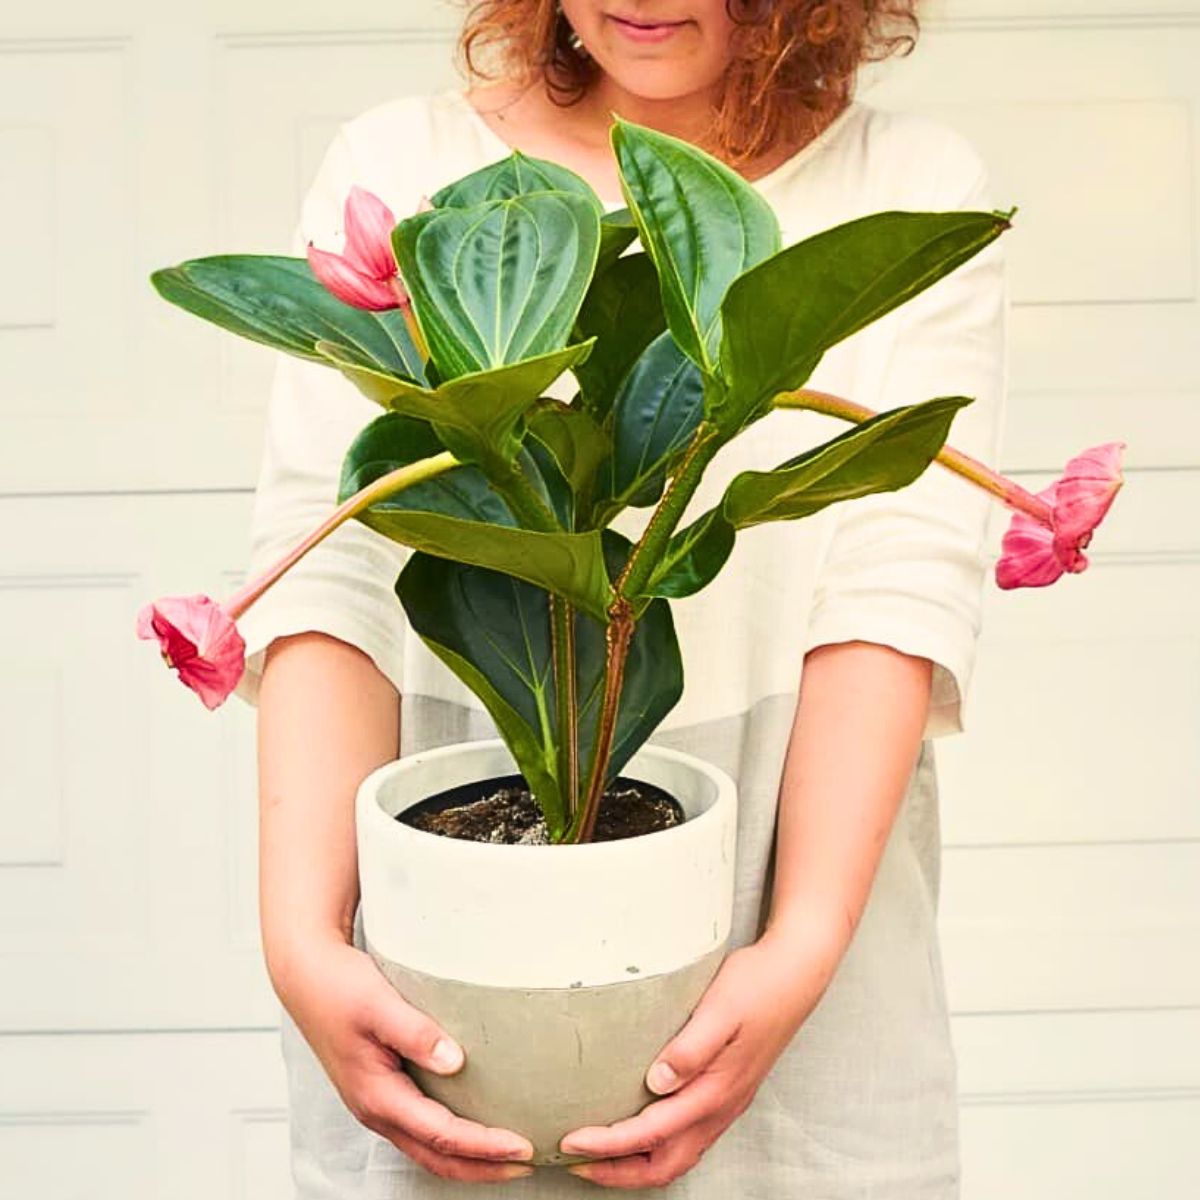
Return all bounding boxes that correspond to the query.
[804,134,1009,738]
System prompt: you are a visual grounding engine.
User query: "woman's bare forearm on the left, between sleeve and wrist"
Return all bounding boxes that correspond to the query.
[258,632,400,991]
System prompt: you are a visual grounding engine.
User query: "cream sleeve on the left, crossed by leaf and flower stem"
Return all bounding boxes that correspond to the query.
[234,128,409,704]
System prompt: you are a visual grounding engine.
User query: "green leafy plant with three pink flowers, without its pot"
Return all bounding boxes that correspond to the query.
[138,112,1122,842]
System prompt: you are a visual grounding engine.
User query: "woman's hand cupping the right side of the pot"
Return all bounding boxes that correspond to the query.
[559,916,845,1188]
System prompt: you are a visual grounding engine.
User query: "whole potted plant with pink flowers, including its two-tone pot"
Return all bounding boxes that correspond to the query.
[139,120,1122,1163]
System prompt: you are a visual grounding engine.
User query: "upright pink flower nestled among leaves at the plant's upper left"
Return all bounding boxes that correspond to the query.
[308,184,408,312]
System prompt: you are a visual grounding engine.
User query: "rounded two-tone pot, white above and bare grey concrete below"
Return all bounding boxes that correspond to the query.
[356,740,737,1164]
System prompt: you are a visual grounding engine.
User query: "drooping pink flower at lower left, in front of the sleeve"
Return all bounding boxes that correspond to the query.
[138,594,246,709]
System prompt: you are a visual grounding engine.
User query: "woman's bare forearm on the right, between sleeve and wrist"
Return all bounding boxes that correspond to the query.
[764,642,932,962]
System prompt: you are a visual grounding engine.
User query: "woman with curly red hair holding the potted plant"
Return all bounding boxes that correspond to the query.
[239,0,1006,1200]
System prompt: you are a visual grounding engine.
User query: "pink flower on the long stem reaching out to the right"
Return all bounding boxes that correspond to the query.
[996,442,1126,588]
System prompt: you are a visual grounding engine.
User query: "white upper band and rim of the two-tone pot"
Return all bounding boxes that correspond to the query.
[356,739,737,989]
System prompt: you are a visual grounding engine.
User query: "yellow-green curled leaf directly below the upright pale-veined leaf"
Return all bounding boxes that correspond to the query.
[320,342,592,462]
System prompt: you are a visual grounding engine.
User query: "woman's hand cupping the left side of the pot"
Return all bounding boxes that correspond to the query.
[269,932,533,1183]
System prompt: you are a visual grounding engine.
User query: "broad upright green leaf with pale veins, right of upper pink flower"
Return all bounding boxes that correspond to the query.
[392,192,600,380]
